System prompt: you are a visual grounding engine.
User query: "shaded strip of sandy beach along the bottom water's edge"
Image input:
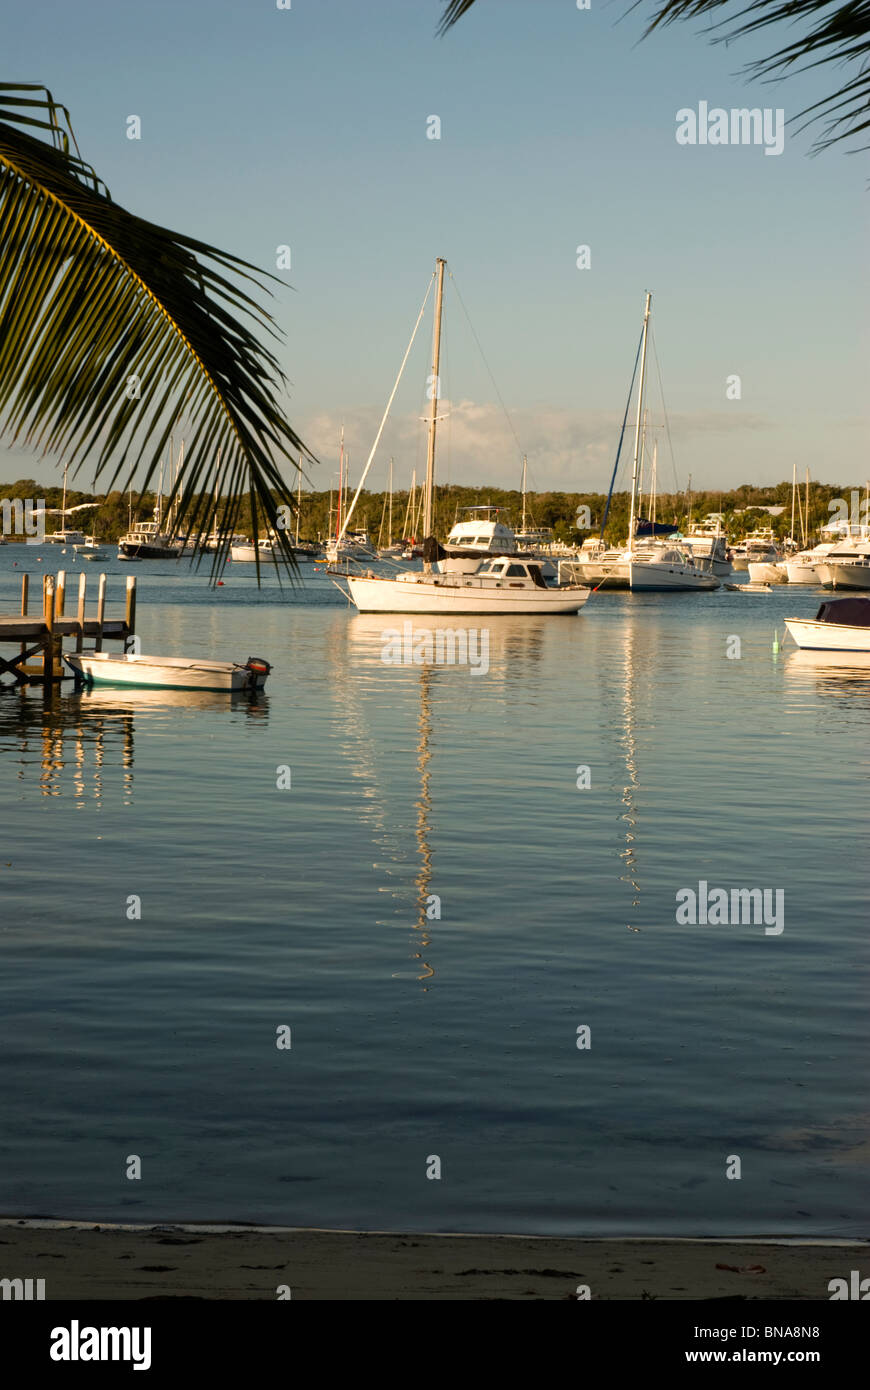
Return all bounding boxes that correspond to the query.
[0,1219,870,1301]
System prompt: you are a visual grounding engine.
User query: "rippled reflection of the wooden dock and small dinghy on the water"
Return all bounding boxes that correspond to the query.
[0,685,268,805]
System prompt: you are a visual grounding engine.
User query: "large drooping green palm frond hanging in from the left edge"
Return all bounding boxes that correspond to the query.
[0,83,314,572]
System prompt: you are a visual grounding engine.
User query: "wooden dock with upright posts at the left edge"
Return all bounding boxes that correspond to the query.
[0,570,136,687]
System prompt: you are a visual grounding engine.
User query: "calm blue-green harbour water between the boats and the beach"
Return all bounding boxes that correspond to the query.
[0,546,870,1236]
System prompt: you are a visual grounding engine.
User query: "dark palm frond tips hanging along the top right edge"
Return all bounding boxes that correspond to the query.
[438,0,870,149]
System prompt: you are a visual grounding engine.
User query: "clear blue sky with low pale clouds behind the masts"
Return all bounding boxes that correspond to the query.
[0,0,870,489]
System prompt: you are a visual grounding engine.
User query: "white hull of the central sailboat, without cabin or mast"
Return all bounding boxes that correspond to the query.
[346,574,591,614]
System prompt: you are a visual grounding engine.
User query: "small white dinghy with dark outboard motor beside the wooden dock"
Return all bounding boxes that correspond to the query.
[64,652,271,692]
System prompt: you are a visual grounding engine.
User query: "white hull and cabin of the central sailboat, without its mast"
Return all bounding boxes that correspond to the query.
[342,557,592,614]
